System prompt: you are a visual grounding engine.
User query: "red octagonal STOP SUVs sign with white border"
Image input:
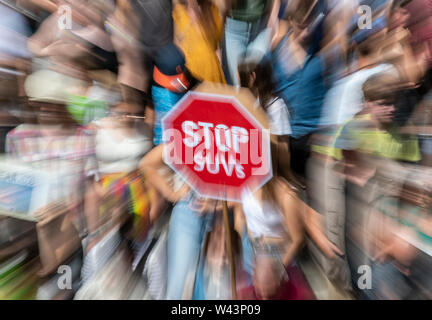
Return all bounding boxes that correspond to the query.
[162,84,272,201]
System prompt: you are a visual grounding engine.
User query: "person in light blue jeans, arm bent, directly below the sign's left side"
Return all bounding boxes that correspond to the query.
[140,144,228,300]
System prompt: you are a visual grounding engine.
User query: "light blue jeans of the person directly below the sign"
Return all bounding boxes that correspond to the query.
[167,202,213,300]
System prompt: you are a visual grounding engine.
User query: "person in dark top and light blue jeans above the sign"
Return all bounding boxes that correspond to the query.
[219,0,280,85]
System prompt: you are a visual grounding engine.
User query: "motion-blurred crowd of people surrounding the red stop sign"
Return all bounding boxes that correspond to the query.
[0,0,432,300]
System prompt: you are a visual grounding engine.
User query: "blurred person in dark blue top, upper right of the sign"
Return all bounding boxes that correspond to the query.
[271,1,328,180]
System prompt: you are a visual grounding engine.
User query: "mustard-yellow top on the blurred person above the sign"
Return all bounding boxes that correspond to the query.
[172,4,225,83]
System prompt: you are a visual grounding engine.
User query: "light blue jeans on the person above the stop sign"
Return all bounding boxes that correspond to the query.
[222,18,271,85]
